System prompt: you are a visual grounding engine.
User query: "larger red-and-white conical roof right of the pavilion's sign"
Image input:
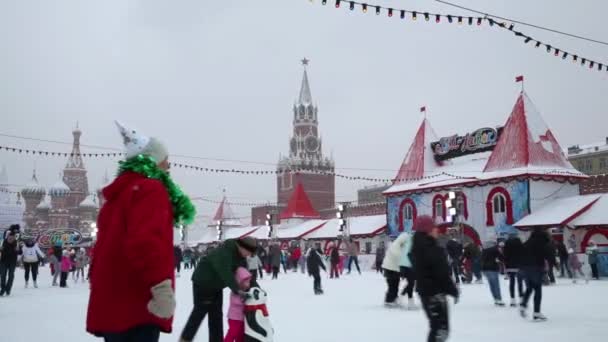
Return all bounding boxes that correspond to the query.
[484,91,573,172]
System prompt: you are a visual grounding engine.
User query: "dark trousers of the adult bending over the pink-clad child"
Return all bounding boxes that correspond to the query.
[182,284,224,342]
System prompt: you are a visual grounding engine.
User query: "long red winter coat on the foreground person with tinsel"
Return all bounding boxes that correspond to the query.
[87,172,175,336]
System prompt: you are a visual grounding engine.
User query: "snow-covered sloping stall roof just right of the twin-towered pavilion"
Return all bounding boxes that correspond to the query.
[514,195,608,227]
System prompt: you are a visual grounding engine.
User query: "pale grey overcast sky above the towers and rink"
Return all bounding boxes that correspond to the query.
[0,0,608,216]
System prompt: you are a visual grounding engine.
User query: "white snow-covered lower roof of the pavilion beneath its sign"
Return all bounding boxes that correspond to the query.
[383,151,587,195]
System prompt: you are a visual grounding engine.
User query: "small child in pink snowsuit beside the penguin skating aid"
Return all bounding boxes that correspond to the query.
[224,268,252,342]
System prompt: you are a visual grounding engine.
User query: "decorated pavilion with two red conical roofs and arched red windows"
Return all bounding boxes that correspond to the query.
[384,91,587,244]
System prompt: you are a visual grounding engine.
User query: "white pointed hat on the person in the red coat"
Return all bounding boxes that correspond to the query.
[114,121,169,163]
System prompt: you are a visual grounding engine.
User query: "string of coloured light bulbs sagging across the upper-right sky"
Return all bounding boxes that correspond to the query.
[314,0,608,72]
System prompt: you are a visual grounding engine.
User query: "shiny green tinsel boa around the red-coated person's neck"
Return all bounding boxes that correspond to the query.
[118,154,196,226]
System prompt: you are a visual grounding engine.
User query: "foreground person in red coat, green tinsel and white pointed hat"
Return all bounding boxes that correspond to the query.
[87,121,196,342]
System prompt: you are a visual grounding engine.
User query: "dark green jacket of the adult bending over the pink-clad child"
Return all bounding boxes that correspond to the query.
[192,240,247,292]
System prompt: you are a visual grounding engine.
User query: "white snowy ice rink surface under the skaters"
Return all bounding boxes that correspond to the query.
[0,267,608,342]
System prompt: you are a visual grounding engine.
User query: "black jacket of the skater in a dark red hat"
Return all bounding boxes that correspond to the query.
[410,232,458,297]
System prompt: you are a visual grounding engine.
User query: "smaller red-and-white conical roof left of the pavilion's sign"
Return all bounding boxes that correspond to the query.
[395,119,438,184]
